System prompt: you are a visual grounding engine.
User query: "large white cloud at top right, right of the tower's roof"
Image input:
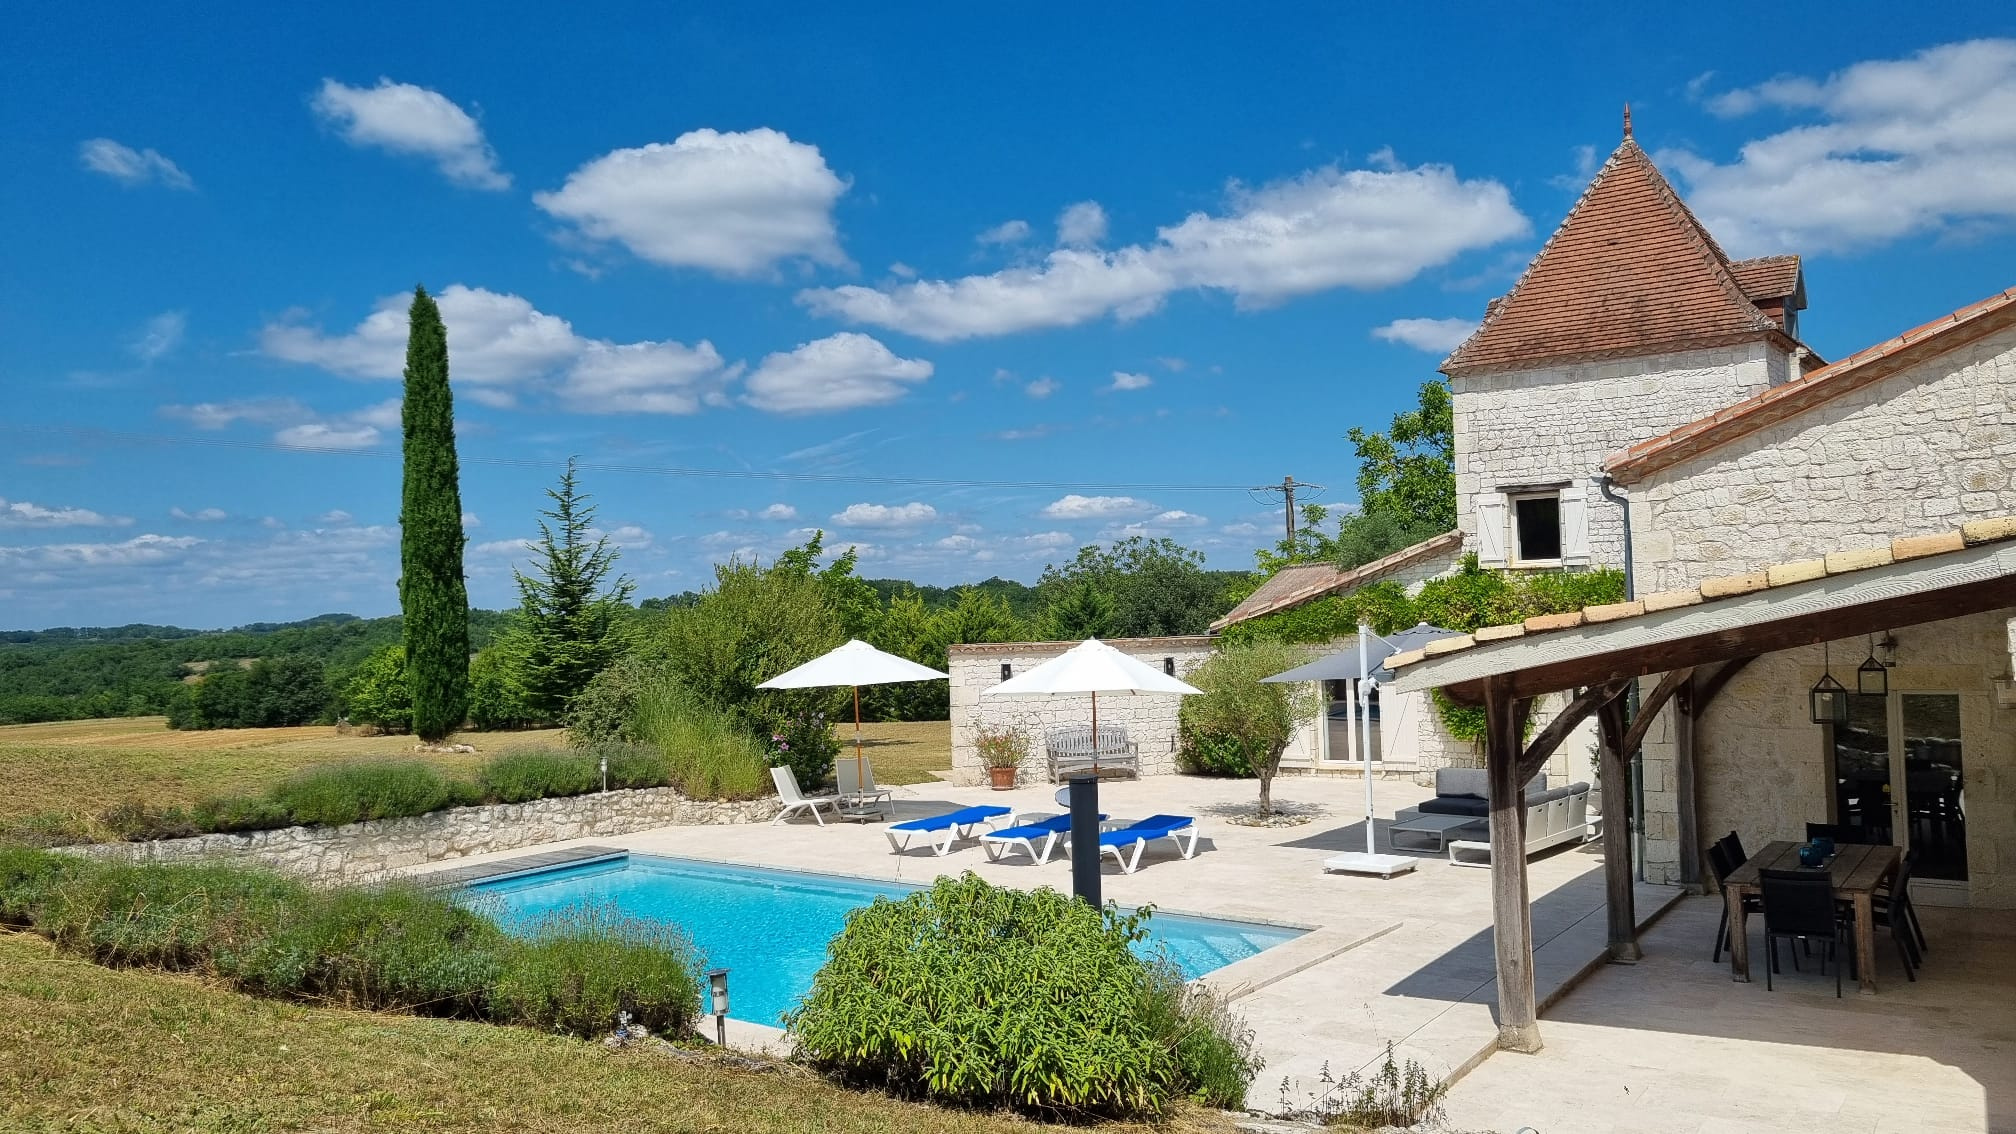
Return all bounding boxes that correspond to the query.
[1657,38,2016,256]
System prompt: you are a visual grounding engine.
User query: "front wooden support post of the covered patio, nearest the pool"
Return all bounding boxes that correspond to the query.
[1484,680,1540,1051]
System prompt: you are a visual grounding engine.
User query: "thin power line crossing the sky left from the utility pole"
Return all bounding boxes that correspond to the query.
[0,424,1257,492]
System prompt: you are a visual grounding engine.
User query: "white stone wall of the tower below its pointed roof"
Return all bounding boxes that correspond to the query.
[1450,334,1790,567]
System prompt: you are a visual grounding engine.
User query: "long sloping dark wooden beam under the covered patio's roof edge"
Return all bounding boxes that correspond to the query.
[1427,577,2016,704]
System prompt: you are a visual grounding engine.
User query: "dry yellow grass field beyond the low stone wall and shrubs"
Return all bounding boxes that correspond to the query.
[0,716,952,823]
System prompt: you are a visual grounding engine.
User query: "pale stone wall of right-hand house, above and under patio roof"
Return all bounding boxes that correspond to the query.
[1631,320,2016,906]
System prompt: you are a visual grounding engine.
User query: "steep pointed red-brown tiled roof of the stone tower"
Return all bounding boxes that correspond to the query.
[1441,137,1798,377]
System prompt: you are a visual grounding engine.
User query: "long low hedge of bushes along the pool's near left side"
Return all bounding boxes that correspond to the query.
[0,845,700,1037]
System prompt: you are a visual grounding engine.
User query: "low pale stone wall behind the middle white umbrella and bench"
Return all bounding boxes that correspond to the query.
[952,636,1214,783]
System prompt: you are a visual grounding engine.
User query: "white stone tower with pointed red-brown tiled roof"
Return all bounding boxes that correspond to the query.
[1441,123,1818,567]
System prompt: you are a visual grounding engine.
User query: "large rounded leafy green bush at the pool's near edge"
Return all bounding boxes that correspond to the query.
[786,874,1260,1118]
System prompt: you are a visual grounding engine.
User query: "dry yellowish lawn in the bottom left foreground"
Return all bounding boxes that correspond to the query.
[0,932,1232,1134]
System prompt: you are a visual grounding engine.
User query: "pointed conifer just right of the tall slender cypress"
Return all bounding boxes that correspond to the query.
[514,458,635,720]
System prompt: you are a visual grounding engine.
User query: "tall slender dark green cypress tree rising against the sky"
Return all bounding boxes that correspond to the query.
[399,287,470,743]
